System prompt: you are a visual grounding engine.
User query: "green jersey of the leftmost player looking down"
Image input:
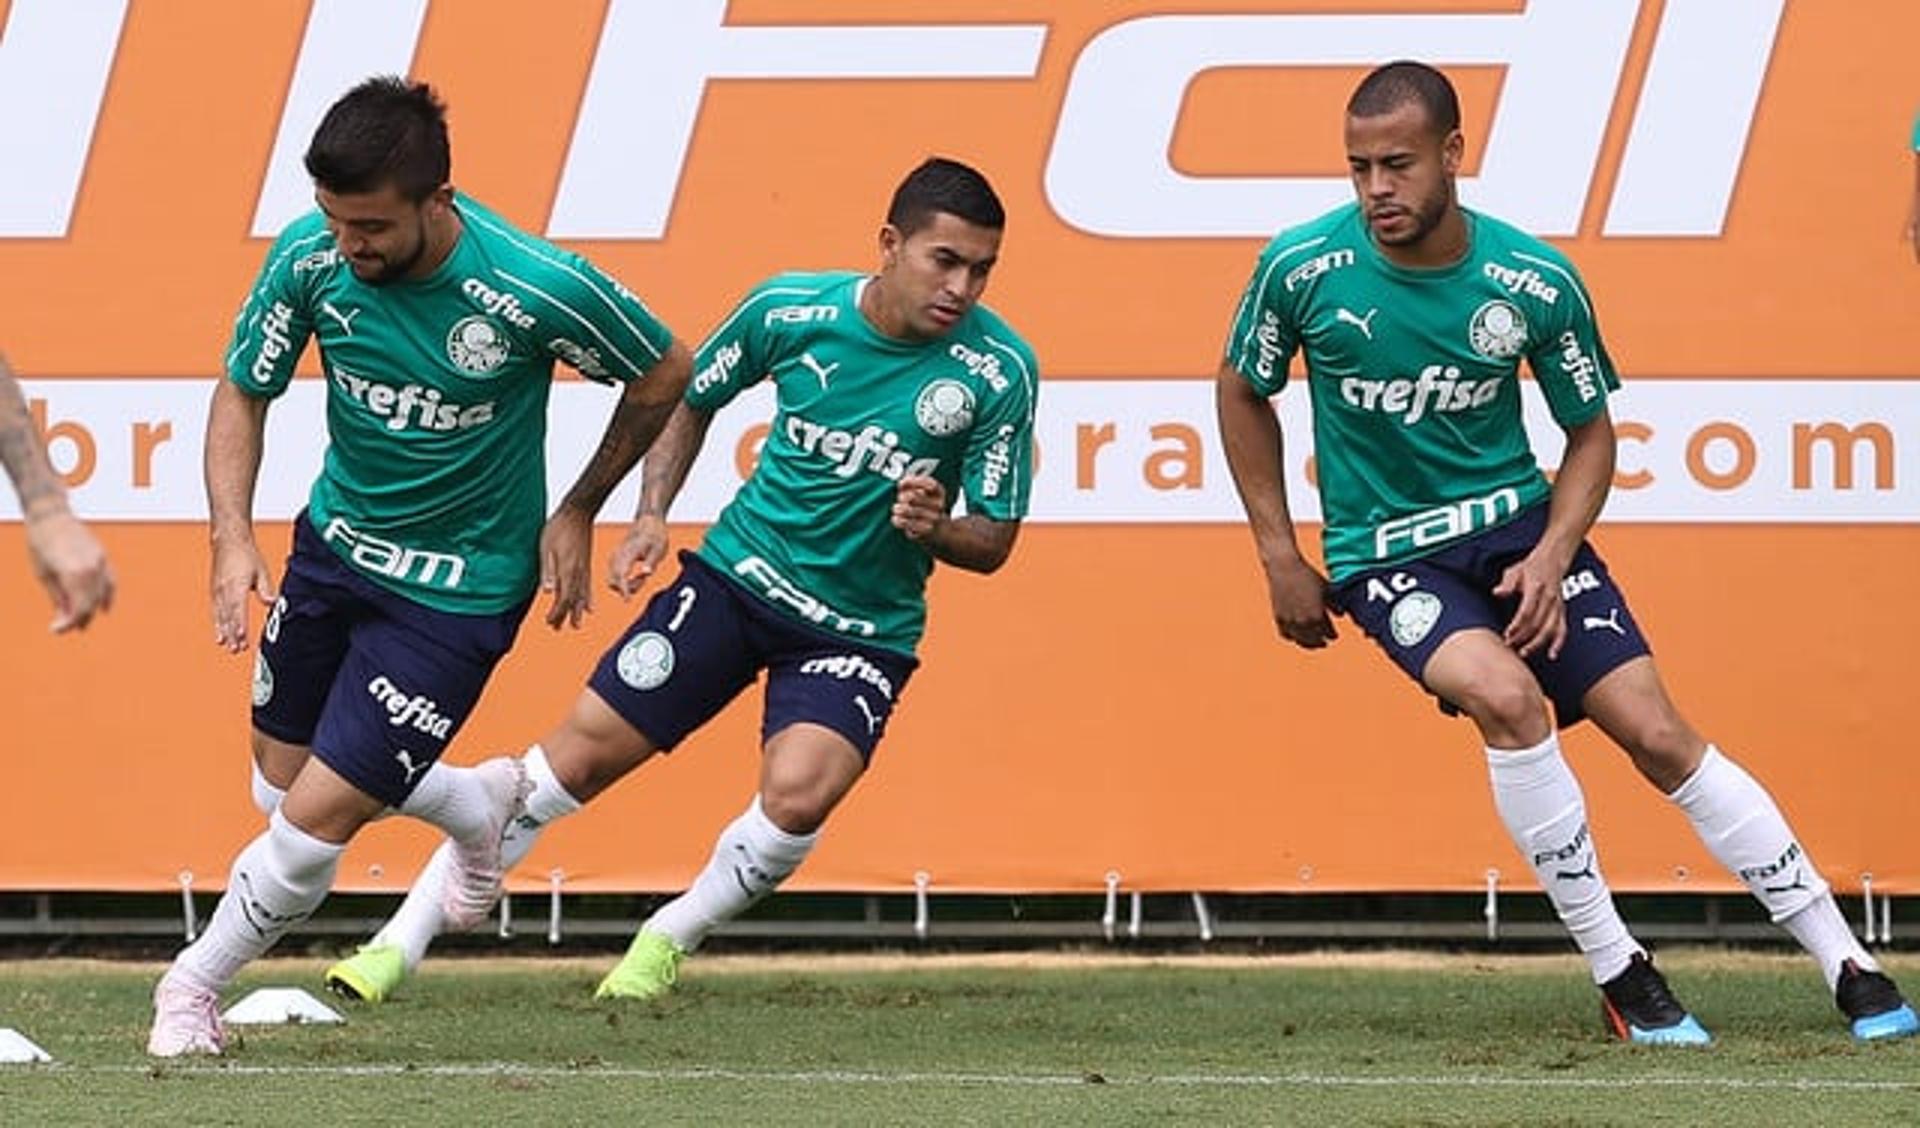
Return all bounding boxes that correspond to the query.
[227,196,672,614]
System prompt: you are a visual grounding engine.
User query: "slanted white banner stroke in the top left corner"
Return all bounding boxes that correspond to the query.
[0,0,127,238]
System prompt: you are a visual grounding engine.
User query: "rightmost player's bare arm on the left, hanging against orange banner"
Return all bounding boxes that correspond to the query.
[1213,356,1338,650]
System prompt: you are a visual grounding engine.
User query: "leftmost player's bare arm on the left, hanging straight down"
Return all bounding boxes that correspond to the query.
[205,380,275,654]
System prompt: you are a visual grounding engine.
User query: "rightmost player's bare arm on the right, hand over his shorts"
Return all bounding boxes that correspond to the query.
[1494,411,1613,658]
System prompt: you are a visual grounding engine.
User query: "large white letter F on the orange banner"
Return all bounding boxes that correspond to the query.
[547,0,1046,240]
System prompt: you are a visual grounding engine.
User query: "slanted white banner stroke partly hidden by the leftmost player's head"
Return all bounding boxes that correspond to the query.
[253,0,426,238]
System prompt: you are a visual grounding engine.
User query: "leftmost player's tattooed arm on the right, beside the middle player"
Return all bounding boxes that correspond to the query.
[540,340,693,629]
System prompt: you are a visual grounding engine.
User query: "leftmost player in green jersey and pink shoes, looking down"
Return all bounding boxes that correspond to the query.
[148,79,691,1057]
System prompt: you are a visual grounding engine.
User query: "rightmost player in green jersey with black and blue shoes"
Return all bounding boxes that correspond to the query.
[1215,61,1920,1044]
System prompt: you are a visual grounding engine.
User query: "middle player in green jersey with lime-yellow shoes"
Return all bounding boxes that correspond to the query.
[326,159,1039,1001]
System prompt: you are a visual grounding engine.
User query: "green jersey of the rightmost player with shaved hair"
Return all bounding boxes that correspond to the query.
[1227,203,1619,579]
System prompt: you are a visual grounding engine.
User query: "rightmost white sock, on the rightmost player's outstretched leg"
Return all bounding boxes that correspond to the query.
[1667,744,1872,986]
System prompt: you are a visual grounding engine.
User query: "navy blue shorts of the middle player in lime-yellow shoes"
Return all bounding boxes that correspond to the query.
[588,552,920,760]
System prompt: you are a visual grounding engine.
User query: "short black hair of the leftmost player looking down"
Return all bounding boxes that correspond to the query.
[307,75,453,203]
